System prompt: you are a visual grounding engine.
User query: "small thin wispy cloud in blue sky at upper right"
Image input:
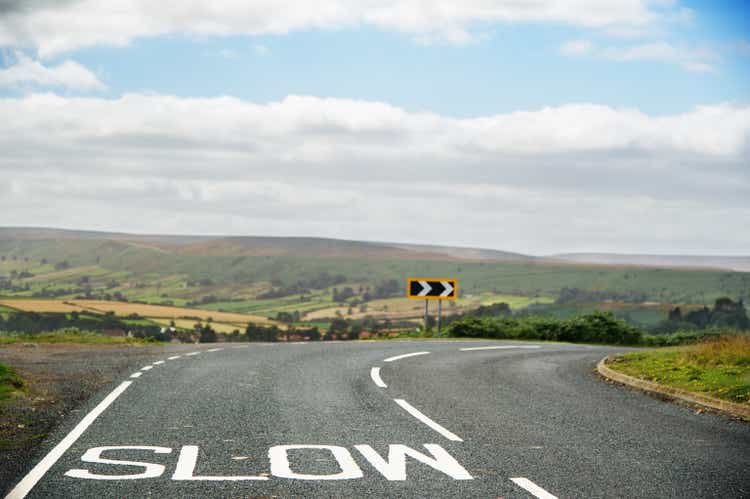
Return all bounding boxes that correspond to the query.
[560,40,718,73]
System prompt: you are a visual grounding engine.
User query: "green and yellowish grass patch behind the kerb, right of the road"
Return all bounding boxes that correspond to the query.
[609,336,750,403]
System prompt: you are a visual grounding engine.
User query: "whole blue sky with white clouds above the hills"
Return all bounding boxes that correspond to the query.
[0,0,750,255]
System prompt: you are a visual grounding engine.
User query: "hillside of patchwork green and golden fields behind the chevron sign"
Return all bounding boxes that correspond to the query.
[0,228,750,329]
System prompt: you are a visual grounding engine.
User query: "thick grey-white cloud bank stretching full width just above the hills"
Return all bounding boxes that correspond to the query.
[0,94,750,253]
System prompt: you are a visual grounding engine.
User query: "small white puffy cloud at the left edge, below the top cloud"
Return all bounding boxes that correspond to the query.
[0,52,107,91]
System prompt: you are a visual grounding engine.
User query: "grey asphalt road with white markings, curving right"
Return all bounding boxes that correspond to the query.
[9,341,750,498]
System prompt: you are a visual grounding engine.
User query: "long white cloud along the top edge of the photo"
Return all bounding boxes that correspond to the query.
[0,0,677,57]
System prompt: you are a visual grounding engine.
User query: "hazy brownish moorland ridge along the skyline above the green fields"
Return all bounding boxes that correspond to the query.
[0,227,750,272]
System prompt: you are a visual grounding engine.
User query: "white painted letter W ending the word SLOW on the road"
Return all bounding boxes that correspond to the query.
[354,444,473,480]
